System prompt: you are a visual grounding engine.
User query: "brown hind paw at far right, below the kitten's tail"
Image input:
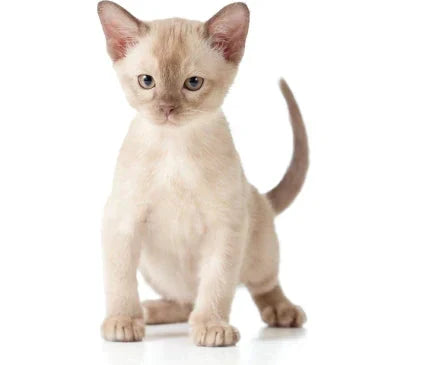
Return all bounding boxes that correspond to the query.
[261,302,306,327]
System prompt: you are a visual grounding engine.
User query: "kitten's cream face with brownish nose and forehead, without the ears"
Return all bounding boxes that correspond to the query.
[115,20,237,123]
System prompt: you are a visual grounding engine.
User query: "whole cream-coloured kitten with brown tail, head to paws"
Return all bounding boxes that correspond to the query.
[98,1,308,346]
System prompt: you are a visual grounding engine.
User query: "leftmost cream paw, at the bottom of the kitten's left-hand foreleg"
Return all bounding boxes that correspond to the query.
[101,316,145,342]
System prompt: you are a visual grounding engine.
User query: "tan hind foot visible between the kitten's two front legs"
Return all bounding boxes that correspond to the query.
[142,299,193,324]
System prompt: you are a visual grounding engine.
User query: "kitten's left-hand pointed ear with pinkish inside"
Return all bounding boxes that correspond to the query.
[98,1,141,61]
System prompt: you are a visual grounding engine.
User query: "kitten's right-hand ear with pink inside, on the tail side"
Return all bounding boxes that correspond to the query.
[205,3,249,63]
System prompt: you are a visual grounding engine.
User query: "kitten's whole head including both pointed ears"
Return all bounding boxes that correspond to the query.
[98,1,249,125]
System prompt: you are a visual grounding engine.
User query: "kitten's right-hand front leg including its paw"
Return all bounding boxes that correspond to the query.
[189,229,243,346]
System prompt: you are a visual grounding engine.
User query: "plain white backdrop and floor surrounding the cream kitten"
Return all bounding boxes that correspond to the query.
[0,0,432,365]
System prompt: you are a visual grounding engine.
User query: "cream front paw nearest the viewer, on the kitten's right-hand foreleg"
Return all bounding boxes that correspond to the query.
[192,321,240,347]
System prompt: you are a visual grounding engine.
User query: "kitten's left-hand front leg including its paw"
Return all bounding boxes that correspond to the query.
[101,201,144,342]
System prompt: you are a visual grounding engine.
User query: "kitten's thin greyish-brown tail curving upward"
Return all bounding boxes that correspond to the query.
[266,79,309,214]
